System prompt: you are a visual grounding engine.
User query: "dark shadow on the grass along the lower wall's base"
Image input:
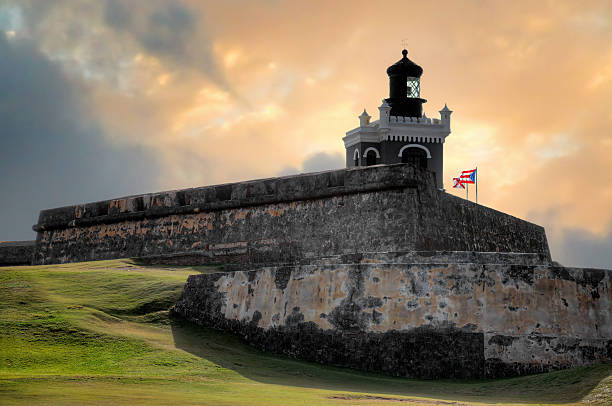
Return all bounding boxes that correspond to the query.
[171,316,612,403]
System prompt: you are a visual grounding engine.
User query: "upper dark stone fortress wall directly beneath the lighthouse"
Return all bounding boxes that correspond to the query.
[34,164,550,264]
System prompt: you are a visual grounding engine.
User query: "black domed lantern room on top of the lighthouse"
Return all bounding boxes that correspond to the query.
[386,49,427,117]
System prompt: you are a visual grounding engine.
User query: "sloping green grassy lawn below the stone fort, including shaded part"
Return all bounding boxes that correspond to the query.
[0,260,612,406]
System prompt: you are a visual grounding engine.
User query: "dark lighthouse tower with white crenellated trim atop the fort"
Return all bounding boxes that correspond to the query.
[343,49,452,189]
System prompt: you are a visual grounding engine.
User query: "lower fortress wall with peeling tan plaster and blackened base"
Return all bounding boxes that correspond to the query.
[174,262,612,378]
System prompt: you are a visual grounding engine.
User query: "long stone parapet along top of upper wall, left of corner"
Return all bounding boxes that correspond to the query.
[33,165,432,232]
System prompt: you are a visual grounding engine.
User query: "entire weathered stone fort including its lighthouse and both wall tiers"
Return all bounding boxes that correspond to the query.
[0,51,612,378]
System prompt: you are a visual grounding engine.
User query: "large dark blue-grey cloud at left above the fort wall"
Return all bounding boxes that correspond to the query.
[0,33,156,239]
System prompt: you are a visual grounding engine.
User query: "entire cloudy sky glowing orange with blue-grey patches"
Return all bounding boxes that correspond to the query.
[0,0,612,268]
